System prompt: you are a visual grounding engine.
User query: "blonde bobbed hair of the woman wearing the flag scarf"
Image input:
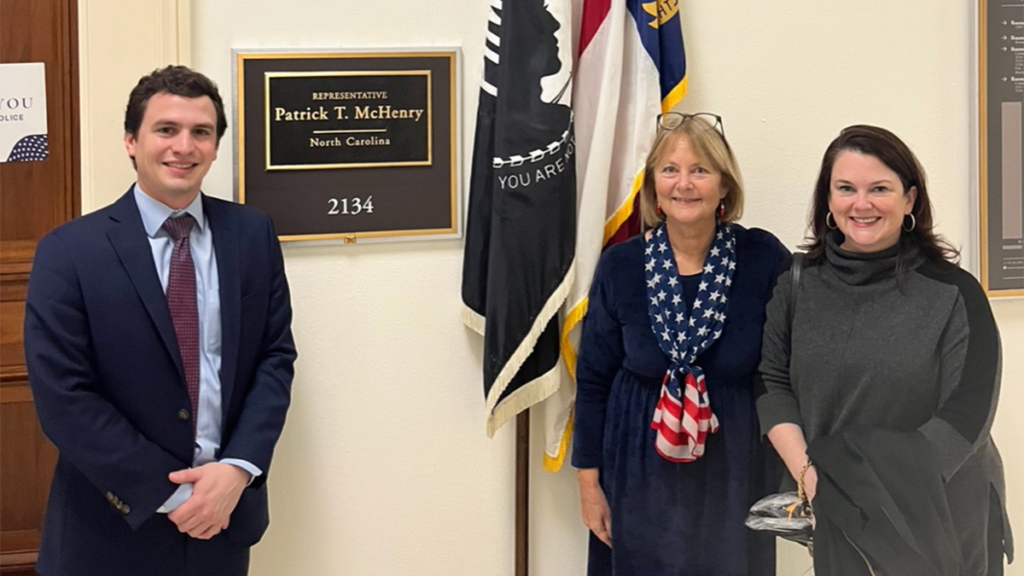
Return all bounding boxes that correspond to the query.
[640,116,743,228]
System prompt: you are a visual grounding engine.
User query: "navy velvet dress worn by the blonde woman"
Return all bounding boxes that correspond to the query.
[572,224,790,576]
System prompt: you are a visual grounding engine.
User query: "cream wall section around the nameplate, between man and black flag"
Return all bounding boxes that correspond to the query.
[193,0,513,576]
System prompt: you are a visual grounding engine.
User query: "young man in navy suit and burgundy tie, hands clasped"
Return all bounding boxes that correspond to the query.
[25,67,296,576]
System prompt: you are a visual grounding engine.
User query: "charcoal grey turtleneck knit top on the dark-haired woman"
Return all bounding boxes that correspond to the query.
[757,233,1013,575]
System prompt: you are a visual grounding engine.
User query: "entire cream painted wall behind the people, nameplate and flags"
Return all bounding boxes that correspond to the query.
[82,0,1024,576]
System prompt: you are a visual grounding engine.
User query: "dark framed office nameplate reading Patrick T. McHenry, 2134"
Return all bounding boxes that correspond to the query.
[233,48,462,243]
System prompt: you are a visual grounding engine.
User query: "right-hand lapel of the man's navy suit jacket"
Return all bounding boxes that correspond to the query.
[203,195,242,410]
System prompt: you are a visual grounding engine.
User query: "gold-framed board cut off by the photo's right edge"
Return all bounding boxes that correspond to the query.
[978,0,1024,297]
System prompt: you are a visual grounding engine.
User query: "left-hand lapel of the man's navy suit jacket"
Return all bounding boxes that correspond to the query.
[106,189,184,381]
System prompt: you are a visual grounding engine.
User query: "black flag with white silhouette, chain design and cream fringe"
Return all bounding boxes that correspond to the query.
[462,0,577,436]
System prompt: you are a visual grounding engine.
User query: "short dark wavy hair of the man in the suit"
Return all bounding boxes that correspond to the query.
[125,66,227,146]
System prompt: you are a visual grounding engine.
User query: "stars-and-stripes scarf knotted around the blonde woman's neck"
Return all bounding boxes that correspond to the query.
[644,223,736,462]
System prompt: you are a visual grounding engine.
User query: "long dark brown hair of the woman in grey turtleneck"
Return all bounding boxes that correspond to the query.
[801,125,959,263]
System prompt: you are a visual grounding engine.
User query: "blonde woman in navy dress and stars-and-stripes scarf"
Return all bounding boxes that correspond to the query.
[572,113,790,576]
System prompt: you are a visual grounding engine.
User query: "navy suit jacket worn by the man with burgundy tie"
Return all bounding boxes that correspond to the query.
[25,189,296,576]
